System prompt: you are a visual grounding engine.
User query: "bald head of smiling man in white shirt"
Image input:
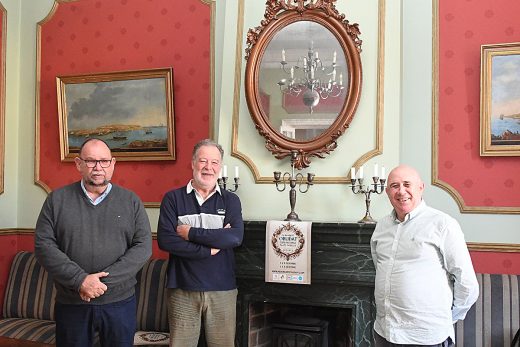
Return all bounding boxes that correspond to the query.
[386,165,424,221]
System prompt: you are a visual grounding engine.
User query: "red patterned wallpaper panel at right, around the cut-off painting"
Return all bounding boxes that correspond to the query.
[437,0,520,210]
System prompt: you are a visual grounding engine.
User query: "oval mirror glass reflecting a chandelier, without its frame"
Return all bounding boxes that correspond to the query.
[258,20,349,141]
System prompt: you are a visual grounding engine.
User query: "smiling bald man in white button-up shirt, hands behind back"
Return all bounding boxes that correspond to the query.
[370,165,479,347]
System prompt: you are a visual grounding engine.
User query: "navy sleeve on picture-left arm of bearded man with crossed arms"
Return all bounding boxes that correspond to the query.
[157,192,211,259]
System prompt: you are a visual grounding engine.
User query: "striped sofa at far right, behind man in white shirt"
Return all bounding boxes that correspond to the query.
[455,274,520,347]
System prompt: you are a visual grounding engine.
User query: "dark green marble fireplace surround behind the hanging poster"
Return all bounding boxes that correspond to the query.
[235,221,375,347]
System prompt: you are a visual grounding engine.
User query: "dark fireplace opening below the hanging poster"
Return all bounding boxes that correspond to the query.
[249,302,353,347]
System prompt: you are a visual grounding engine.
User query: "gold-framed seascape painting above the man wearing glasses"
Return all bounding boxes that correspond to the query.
[56,68,175,161]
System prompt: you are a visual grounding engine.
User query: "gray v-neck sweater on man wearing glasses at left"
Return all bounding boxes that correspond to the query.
[35,182,152,304]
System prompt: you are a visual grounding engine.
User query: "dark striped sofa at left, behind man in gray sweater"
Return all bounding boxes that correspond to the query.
[0,251,169,345]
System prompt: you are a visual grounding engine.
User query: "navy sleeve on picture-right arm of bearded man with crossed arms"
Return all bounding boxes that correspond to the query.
[189,193,244,249]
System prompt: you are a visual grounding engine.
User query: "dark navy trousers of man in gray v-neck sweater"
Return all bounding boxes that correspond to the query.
[54,295,136,347]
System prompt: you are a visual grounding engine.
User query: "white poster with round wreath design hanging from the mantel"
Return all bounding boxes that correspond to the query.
[265,221,312,284]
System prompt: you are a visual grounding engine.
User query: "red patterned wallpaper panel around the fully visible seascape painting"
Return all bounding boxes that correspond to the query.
[37,0,214,203]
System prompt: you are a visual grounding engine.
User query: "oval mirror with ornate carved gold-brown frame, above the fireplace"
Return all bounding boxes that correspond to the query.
[245,0,362,169]
